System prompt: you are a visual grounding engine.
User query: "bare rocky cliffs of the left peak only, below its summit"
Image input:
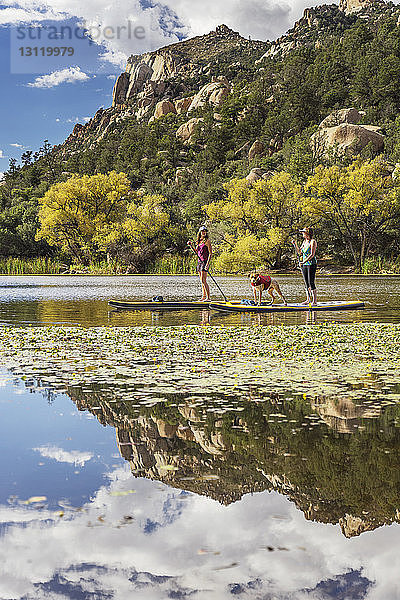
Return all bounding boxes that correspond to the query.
[64,25,269,150]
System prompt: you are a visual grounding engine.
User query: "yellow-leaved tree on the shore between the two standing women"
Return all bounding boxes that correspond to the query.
[203,171,302,272]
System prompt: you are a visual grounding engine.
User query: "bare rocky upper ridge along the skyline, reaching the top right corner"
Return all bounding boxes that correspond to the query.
[62,0,400,153]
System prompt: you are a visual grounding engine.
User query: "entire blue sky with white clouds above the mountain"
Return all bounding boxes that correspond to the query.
[0,0,328,178]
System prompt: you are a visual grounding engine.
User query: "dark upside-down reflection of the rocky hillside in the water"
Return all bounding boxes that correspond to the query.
[30,387,400,537]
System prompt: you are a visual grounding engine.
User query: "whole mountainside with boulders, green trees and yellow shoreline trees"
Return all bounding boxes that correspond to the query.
[0,1,400,272]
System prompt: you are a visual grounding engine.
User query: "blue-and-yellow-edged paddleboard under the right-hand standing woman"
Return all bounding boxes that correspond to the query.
[210,300,365,313]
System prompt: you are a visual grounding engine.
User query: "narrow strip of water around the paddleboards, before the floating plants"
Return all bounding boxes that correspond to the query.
[0,275,400,327]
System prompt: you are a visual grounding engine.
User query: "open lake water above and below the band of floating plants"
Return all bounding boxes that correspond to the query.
[0,277,400,600]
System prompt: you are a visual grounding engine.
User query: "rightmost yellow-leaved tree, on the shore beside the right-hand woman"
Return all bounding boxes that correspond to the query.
[303,157,400,269]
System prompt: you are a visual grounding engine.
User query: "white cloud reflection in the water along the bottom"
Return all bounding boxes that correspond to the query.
[0,468,400,600]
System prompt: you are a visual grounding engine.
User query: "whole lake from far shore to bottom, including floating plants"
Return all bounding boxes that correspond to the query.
[0,276,400,600]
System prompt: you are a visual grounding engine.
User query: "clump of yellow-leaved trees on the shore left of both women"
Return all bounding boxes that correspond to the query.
[37,171,169,263]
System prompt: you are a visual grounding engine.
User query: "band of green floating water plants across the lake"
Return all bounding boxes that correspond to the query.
[0,323,400,405]
